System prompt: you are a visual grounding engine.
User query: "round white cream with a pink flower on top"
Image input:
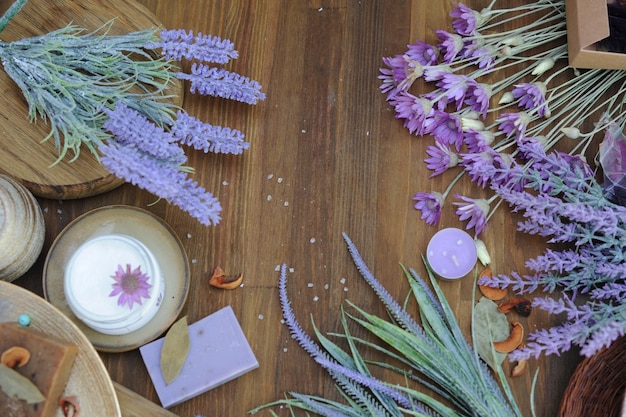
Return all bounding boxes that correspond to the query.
[64,234,165,335]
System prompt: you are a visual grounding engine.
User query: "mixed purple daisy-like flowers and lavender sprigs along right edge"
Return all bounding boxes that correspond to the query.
[379,0,626,359]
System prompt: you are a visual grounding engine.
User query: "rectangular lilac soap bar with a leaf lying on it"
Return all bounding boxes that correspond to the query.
[139,306,259,408]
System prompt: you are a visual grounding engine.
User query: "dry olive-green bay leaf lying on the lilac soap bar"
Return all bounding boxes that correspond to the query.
[161,316,190,385]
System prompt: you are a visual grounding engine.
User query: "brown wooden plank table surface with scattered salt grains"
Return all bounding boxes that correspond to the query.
[16,0,579,417]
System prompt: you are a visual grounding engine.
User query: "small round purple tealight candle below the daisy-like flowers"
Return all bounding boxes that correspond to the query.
[426,227,478,279]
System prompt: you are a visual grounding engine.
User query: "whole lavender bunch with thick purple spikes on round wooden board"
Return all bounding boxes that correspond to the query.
[0,0,265,225]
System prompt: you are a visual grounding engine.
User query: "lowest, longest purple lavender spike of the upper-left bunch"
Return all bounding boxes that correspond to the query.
[98,141,222,226]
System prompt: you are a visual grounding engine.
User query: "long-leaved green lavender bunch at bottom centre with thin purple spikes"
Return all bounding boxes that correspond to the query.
[251,234,522,417]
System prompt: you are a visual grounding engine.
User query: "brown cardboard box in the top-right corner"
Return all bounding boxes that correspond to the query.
[565,0,626,70]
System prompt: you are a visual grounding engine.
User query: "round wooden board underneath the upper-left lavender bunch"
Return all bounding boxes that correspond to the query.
[0,0,182,199]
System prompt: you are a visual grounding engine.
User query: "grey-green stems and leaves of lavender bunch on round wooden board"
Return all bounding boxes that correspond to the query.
[0,23,176,160]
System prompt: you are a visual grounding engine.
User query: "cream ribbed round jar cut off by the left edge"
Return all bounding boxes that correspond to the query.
[0,174,45,282]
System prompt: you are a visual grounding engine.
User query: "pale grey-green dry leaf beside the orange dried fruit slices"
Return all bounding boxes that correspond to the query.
[474,297,511,369]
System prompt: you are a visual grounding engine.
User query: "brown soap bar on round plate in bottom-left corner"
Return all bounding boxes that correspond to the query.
[0,323,78,417]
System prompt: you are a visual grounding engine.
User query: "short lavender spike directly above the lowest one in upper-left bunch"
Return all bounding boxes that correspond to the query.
[103,103,186,164]
